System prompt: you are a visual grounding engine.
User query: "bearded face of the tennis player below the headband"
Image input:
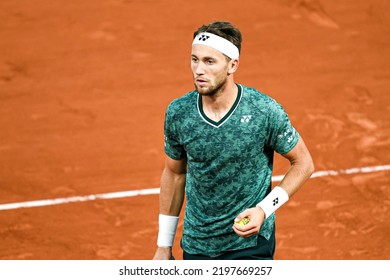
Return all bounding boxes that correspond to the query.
[191,45,230,96]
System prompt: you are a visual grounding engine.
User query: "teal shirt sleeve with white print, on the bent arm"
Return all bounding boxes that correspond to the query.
[268,102,300,154]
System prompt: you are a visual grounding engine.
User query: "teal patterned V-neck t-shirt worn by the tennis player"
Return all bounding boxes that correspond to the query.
[164,85,299,256]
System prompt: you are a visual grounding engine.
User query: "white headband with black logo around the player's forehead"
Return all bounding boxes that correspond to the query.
[192,32,240,59]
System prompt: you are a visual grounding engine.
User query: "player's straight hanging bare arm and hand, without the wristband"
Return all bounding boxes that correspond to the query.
[153,157,187,260]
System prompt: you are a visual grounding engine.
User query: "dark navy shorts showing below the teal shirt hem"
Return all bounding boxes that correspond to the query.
[183,227,276,260]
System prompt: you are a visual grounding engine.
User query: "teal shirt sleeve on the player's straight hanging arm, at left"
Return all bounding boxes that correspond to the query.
[164,105,185,160]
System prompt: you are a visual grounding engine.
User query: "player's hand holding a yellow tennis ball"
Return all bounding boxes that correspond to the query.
[233,207,265,238]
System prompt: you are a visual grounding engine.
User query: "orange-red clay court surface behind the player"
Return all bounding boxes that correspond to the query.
[0,0,390,260]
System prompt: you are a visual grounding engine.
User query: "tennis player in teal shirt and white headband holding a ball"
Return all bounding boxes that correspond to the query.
[154,21,314,260]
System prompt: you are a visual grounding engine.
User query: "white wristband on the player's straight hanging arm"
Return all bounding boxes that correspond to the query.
[157,214,179,247]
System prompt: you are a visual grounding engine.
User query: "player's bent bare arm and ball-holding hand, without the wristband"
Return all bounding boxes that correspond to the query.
[233,138,314,237]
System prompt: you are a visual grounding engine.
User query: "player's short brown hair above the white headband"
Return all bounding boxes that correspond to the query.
[194,21,242,53]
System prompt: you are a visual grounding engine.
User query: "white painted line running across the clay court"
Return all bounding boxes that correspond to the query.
[0,164,390,211]
